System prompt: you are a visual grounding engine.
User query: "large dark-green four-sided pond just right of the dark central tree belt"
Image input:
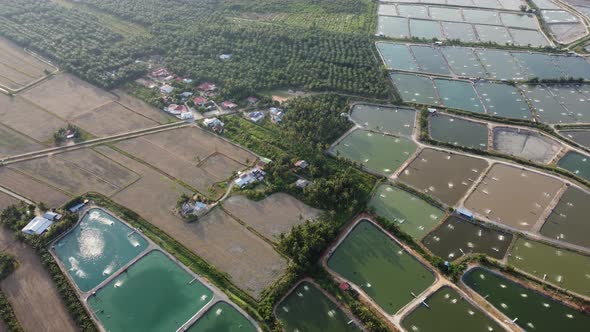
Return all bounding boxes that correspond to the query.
[328,220,435,314]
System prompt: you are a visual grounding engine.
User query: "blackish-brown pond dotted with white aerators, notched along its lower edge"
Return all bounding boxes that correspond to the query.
[422,216,512,261]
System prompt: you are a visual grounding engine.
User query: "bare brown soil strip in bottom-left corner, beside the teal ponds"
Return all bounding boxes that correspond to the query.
[0,228,77,332]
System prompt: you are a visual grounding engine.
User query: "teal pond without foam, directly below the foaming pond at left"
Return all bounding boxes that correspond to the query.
[88,251,213,332]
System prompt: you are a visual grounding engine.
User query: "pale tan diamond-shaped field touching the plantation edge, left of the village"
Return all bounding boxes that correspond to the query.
[21,74,116,120]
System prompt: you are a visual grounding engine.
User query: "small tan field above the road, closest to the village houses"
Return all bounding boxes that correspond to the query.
[72,103,158,137]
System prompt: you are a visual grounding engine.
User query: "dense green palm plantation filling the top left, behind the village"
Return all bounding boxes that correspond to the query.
[0,0,388,99]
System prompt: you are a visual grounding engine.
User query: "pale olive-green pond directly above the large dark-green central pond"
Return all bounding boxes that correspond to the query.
[369,184,444,240]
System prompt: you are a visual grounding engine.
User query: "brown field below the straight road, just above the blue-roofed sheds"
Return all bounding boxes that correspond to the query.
[9,150,137,196]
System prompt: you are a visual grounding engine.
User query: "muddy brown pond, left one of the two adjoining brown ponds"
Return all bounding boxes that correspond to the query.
[399,149,488,205]
